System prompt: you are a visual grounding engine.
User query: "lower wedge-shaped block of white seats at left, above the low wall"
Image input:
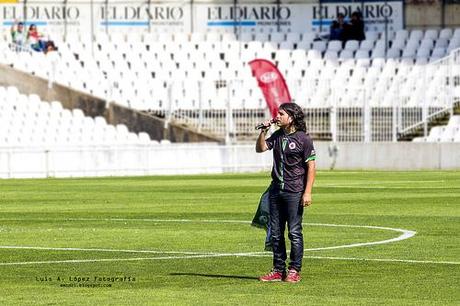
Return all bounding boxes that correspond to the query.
[0,87,157,147]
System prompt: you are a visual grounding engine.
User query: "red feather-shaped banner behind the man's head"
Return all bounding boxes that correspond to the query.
[249,59,291,118]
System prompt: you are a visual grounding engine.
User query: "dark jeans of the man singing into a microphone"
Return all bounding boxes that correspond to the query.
[270,188,304,272]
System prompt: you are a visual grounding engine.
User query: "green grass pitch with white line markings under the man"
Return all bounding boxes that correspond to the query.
[0,171,460,306]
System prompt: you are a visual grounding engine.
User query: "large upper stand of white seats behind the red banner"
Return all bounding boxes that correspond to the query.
[1,29,460,142]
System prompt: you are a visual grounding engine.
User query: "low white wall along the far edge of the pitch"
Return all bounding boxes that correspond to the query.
[0,142,460,178]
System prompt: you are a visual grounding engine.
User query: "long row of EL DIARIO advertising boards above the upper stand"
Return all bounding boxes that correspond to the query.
[0,0,404,33]
